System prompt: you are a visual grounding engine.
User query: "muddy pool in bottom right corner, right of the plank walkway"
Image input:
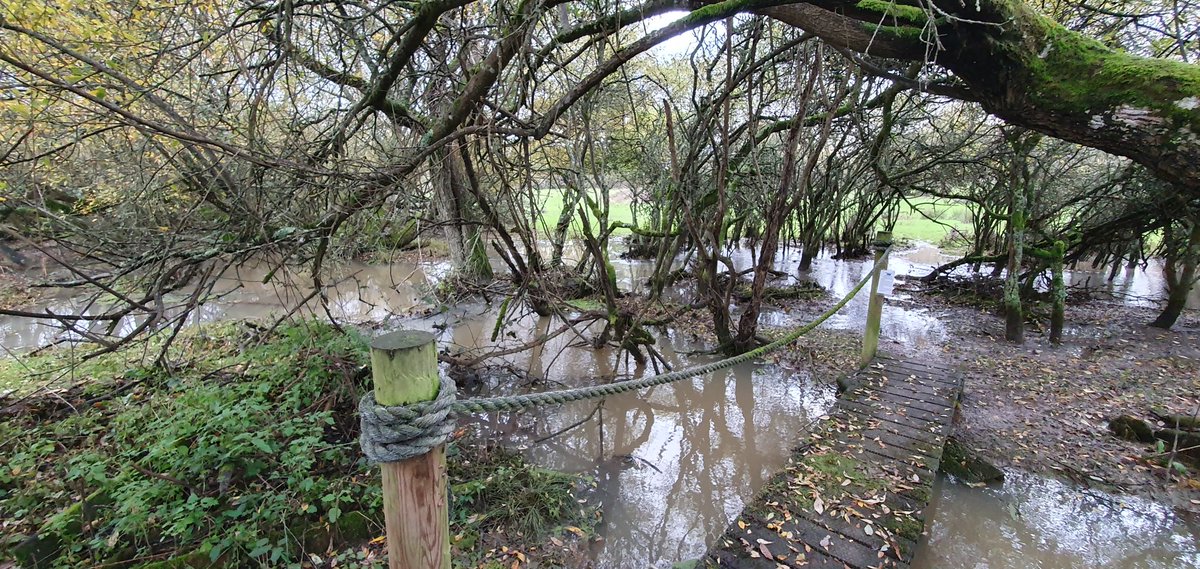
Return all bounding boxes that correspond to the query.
[912,471,1200,569]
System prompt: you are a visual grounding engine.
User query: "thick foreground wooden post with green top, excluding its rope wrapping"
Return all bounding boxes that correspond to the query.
[371,330,450,569]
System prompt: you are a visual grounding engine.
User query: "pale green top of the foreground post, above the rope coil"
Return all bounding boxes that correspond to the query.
[371,330,440,406]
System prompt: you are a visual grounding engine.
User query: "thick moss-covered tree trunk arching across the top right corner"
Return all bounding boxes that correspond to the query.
[757,0,1200,197]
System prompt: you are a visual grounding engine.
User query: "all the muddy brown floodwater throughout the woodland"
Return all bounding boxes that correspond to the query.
[0,247,1200,569]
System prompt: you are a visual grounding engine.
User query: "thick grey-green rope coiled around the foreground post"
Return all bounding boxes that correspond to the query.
[359,377,457,463]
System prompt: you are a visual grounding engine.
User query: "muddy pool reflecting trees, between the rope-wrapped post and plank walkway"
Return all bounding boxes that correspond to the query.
[440,282,833,568]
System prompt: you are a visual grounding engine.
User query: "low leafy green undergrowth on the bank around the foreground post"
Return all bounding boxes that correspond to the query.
[0,322,592,568]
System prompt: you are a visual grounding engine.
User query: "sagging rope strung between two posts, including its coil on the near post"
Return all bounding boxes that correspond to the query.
[359,247,890,462]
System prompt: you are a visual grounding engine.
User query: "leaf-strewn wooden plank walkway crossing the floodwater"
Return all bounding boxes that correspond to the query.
[700,357,962,569]
